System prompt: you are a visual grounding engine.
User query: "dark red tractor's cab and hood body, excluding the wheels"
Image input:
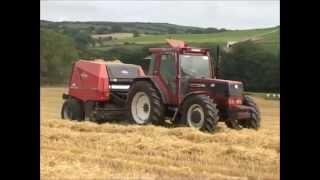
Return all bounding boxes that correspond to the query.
[146,39,242,106]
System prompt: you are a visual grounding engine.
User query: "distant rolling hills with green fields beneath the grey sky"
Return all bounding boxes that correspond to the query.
[40,20,280,53]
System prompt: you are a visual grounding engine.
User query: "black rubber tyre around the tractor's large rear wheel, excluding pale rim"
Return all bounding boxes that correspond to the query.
[127,81,165,125]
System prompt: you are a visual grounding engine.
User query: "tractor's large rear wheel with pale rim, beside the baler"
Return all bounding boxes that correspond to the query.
[128,81,165,125]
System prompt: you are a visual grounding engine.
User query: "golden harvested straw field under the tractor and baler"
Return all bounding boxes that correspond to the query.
[40,88,280,180]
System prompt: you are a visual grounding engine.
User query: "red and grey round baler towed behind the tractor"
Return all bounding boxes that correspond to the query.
[61,60,144,122]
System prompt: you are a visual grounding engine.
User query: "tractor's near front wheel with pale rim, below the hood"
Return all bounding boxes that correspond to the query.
[178,94,219,132]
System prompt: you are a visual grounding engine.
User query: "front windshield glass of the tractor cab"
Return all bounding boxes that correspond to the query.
[180,55,210,77]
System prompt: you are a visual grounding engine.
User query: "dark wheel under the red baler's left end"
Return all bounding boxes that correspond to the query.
[61,99,84,121]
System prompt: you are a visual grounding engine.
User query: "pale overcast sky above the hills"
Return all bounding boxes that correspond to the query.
[40,0,280,29]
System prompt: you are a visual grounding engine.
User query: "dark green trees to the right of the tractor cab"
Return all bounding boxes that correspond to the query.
[221,41,280,91]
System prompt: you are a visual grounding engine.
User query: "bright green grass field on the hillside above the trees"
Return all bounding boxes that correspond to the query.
[92,27,280,53]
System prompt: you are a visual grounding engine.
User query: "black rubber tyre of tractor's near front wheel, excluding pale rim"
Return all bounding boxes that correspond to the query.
[177,94,219,132]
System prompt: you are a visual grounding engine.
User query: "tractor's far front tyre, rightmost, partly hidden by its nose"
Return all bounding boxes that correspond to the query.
[239,96,261,130]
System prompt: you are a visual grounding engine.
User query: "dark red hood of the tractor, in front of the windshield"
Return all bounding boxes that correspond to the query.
[188,78,243,96]
